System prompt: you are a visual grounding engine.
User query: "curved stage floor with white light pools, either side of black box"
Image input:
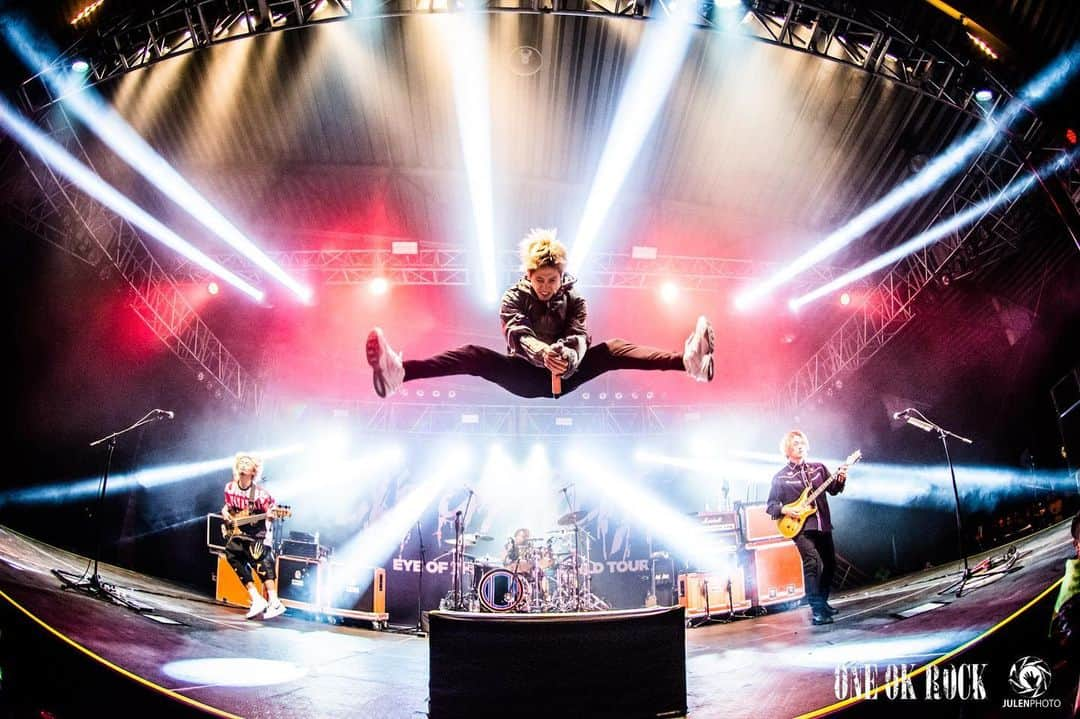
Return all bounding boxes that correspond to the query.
[0,523,1070,719]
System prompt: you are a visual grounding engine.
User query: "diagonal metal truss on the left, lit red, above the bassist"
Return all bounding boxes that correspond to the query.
[5,107,262,412]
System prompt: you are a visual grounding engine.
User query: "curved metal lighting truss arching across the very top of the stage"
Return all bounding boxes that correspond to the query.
[23,0,996,118]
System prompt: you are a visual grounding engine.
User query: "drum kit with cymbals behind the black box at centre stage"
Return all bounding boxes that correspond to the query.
[440,503,610,612]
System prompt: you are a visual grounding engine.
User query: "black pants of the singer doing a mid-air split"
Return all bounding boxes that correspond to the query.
[404,339,686,397]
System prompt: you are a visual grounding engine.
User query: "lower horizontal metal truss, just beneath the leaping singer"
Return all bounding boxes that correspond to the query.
[269,399,719,437]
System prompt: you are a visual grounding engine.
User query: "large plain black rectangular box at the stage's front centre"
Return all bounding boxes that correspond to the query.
[428,607,687,719]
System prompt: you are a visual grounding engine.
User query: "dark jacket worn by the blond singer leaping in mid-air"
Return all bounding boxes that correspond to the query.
[499,274,589,377]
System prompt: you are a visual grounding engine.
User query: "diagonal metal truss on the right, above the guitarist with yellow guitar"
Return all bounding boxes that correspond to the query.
[773,121,1039,412]
